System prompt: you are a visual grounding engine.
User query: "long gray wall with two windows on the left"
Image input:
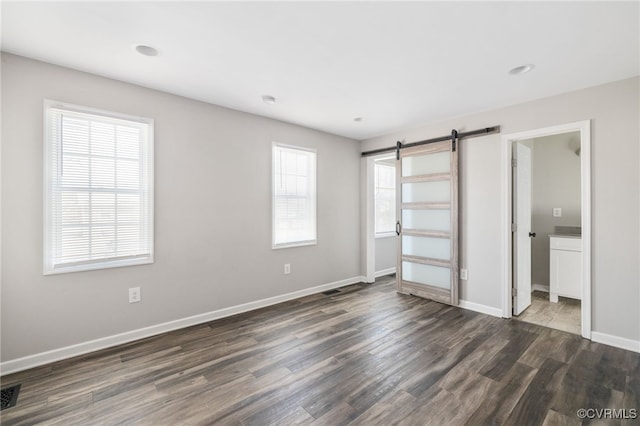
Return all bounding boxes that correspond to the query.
[1,54,360,362]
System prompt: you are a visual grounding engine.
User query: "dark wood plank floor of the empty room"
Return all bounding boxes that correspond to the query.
[1,278,640,425]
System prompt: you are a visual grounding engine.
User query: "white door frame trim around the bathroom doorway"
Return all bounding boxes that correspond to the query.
[500,120,591,339]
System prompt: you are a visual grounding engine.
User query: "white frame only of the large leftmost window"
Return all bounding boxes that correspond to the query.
[42,99,155,275]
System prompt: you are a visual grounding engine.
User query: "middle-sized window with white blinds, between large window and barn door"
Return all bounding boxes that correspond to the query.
[272,143,316,248]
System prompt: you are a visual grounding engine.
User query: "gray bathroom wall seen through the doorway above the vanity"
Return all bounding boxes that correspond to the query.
[531,132,581,286]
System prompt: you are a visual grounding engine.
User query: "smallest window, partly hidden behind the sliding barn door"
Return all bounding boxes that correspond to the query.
[375,162,396,237]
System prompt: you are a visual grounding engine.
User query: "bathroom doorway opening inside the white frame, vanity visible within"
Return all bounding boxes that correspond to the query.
[512,131,582,334]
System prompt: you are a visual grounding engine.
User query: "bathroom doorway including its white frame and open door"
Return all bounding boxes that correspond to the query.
[502,121,591,339]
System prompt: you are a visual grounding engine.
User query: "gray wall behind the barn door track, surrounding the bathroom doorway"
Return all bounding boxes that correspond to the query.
[361,77,640,341]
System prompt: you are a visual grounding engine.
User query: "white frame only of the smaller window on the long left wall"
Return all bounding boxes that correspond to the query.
[271,142,318,250]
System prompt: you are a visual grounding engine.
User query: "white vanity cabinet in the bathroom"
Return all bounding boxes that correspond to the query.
[549,235,582,303]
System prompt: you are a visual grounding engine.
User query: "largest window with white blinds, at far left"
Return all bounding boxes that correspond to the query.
[44,101,153,274]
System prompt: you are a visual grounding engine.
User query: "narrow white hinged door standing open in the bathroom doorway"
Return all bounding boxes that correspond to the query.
[513,141,535,315]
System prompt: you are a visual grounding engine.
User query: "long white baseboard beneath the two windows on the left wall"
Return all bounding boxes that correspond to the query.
[0,276,364,376]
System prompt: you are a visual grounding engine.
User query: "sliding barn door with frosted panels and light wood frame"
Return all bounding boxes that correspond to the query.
[396,140,458,305]
